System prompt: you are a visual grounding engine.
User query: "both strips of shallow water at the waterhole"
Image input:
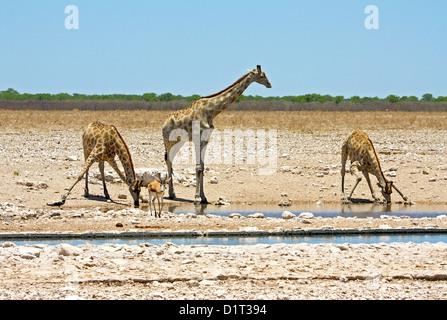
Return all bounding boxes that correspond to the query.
[6,203,447,245]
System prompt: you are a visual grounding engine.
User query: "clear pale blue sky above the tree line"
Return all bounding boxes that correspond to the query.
[0,0,447,97]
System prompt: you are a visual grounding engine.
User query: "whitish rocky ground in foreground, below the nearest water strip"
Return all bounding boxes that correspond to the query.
[0,242,447,300]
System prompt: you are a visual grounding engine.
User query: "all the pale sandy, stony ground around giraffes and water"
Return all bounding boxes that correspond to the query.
[0,112,447,299]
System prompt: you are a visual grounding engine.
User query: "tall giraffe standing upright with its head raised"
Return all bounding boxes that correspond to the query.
[162,65,272,204]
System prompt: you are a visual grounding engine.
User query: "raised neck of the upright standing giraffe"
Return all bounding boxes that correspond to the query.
[198,72,253,119]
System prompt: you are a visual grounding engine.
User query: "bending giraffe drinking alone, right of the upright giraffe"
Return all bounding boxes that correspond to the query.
[341,129,408,204]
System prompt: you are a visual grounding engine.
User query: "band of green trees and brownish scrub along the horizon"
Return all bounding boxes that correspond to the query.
[0,88,447,112]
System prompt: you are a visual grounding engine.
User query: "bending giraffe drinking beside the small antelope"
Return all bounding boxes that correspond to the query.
[48,121,142,207]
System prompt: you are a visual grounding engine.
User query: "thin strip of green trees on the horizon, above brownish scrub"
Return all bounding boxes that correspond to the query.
[0,88,447,104]
